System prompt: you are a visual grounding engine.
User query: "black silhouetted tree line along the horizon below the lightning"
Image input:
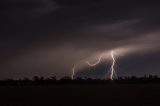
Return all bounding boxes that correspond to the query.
[0,75,160,86]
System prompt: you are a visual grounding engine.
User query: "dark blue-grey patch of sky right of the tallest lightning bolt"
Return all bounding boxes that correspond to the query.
[116,52,160,76]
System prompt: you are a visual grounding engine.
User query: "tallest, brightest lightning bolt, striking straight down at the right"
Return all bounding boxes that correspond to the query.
[110,50,116,80]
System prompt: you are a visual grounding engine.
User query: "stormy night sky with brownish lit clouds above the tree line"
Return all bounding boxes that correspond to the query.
[0,0,160,79]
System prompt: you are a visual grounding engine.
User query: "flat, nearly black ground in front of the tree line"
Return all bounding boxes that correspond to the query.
[0,84,160,106]
